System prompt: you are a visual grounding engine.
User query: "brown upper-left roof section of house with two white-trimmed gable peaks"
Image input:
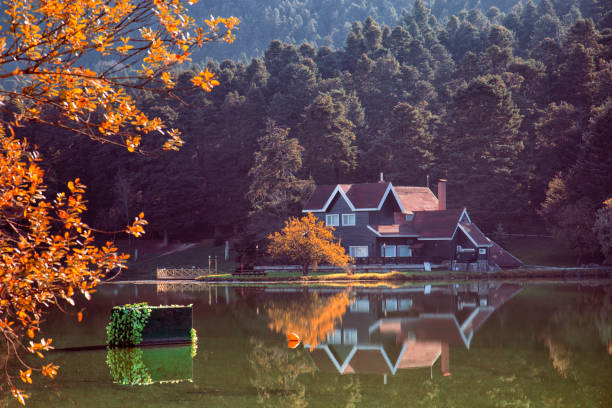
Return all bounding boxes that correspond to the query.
[302,183,403,212]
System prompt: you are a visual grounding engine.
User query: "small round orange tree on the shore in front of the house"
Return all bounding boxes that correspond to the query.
[268,213,351,276]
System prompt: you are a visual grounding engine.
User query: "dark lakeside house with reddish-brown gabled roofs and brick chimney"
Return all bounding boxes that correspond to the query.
[302,175,522,270]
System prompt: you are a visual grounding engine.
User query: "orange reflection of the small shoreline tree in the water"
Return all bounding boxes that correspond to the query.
[266,291,351,350]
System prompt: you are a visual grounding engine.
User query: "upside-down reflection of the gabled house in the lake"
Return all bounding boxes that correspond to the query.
[304,283,522,383]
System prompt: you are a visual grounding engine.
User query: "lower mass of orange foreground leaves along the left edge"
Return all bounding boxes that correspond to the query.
[0,127,146,403]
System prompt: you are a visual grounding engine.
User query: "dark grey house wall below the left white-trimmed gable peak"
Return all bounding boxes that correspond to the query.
[314,194,376,256]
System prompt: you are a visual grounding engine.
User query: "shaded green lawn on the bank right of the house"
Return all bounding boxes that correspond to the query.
[504,237,576,266]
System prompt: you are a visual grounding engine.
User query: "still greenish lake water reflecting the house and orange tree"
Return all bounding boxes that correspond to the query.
[4,282,612,407]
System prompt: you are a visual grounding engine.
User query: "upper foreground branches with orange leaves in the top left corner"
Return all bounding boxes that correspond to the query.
[0,0,239,155]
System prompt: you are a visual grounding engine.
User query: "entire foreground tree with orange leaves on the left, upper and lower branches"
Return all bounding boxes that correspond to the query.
[0,0,239,404]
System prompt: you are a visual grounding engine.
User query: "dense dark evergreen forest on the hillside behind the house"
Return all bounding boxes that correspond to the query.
[10,0,612,257]
